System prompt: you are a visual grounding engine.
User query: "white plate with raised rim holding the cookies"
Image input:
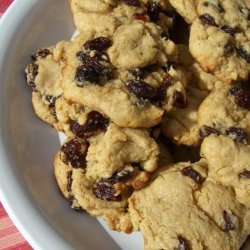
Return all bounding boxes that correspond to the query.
[0,0,143,250]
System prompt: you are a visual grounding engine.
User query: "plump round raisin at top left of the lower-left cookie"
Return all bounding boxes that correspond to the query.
[61,139,87,168]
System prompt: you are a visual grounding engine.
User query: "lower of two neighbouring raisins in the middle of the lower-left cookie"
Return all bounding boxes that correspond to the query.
[93,182,121,201]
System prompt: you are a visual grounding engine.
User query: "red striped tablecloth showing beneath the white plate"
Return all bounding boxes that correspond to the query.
[0,0,32,250]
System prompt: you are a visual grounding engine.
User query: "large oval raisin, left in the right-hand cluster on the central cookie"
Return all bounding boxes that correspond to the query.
[126,80,157,100]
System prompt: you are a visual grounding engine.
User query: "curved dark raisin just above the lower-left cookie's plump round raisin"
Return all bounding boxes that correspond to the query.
[71,111,109,138]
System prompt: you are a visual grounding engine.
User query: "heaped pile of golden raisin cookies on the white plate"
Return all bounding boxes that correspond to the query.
[25,0,250,250]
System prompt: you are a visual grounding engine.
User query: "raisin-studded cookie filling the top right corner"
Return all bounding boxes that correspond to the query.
[189,0,250,84]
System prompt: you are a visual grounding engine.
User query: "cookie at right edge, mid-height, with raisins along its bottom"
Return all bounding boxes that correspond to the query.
[198,85,250,144]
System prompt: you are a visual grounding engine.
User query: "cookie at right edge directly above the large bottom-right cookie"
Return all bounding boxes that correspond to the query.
[201,135,250,208]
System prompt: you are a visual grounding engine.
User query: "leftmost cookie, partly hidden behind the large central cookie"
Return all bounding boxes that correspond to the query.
[25,41,70,130]
